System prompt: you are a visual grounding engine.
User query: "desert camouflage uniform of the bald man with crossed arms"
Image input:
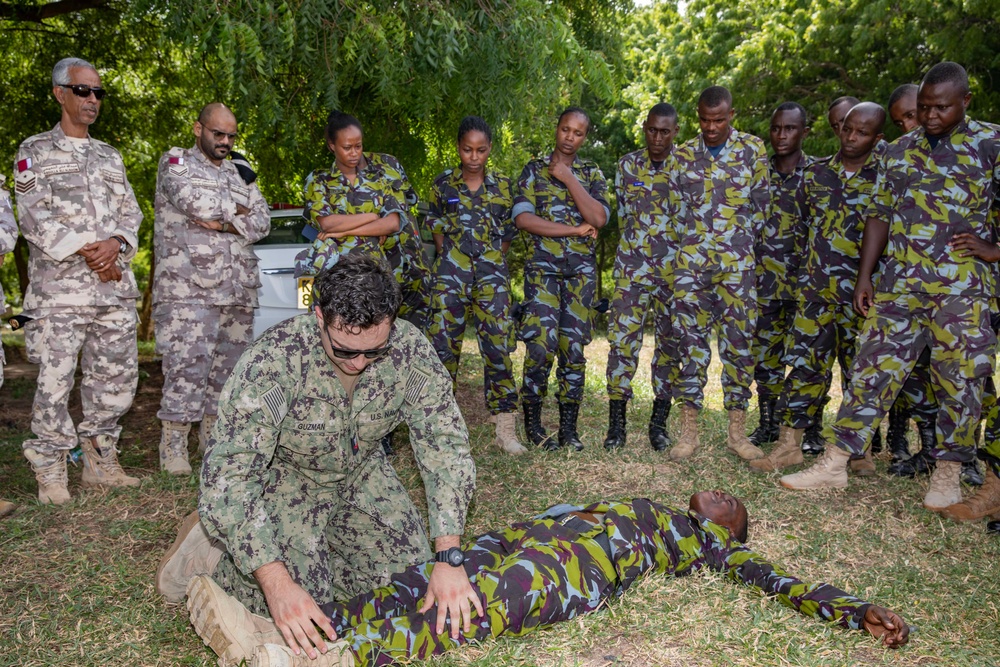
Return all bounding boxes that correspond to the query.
[153,146,271,423]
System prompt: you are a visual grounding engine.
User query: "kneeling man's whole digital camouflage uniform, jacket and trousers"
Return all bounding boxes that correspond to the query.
[198,314,475,614]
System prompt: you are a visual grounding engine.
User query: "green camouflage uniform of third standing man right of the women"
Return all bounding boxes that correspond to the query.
[754,153,814,400]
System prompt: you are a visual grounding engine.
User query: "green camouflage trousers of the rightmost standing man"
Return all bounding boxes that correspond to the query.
[828,293,996,461]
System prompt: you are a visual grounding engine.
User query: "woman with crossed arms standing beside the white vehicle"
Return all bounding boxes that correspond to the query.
[296,111,405,275]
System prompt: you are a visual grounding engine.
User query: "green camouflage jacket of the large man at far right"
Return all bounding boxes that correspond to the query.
[868,118,1000,297]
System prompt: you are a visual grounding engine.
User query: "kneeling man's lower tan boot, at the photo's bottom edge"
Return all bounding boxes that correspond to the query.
[187,575,286,667]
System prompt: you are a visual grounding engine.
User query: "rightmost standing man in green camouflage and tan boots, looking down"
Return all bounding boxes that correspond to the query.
[781,62,1000,511]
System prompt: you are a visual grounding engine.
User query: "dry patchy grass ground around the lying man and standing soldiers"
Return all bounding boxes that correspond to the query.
[0,338,1000,667]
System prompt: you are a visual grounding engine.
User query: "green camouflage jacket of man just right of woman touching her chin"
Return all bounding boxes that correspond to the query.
[614,148,676,282]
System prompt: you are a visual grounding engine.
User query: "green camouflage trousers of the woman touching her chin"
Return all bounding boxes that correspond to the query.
[521,265,597,403]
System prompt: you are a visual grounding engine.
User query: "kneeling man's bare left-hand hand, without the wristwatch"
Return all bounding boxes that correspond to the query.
[254,562,337,660]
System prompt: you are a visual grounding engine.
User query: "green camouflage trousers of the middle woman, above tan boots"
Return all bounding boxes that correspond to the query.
[429,276,517,415]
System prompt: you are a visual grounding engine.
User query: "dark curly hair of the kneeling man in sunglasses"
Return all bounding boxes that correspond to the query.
[314,253,402,330]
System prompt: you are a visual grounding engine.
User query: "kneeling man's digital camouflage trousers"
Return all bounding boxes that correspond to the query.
[212,447,432,615]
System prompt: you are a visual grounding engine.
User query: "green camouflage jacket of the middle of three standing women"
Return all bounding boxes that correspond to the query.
[427,168,517,285]
